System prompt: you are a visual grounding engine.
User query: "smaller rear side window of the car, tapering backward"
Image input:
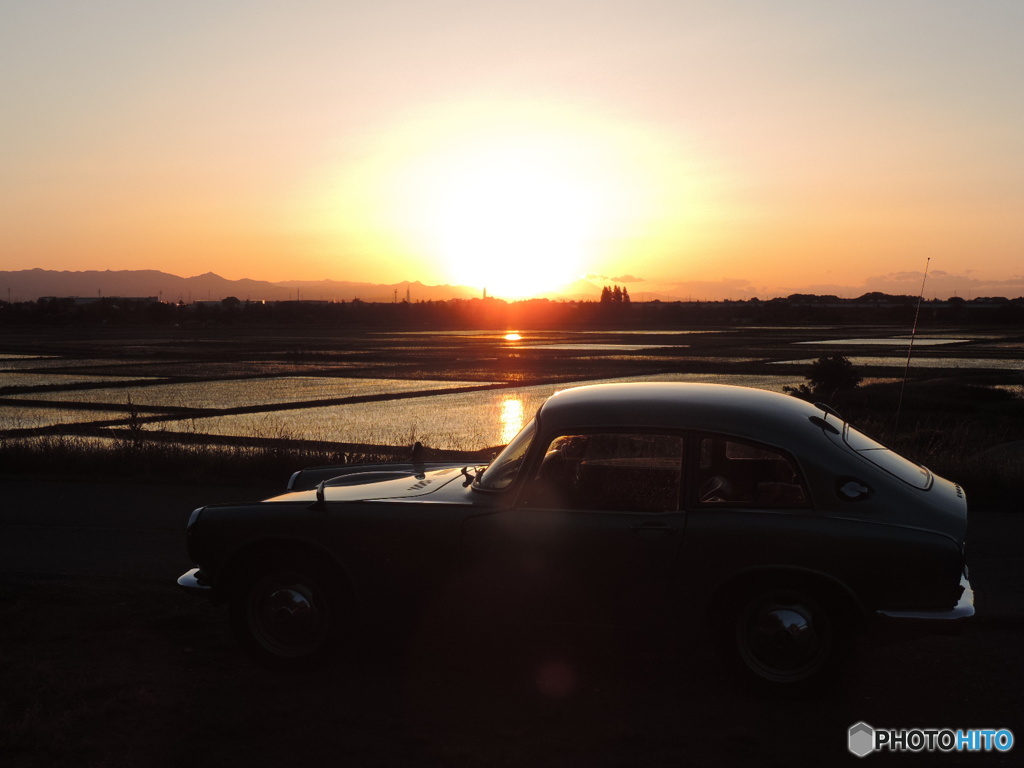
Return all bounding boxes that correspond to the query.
[697,436,810,509]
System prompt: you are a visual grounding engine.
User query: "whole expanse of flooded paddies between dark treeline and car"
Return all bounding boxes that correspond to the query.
[0,327,1024,451]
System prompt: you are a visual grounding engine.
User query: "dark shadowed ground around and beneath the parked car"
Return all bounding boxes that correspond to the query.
[0,480,1024,768]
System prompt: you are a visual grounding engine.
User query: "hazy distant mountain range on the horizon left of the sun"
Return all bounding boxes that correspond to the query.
[0,269,516,302]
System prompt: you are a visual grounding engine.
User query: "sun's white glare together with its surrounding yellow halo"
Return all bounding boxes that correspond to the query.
[309,100,700,299]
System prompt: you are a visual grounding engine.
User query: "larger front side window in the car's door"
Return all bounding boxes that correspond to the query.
[521,432,683,512]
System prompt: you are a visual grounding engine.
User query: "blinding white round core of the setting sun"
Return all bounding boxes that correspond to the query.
[421,141,600,299]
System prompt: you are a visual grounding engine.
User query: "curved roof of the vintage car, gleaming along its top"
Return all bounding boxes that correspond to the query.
[538,382,840,447]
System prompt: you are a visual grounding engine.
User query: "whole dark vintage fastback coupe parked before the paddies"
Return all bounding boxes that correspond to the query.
[178,383,974,684]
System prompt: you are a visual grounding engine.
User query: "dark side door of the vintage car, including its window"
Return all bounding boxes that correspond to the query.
[462,431,685,624]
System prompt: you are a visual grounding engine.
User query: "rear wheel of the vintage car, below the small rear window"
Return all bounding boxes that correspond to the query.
[727,586,849,688]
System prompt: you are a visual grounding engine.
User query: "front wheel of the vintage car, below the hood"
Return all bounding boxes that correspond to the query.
[230,563,344,670]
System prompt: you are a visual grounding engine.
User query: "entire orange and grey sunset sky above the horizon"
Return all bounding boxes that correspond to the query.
[0,0,1024,299]
